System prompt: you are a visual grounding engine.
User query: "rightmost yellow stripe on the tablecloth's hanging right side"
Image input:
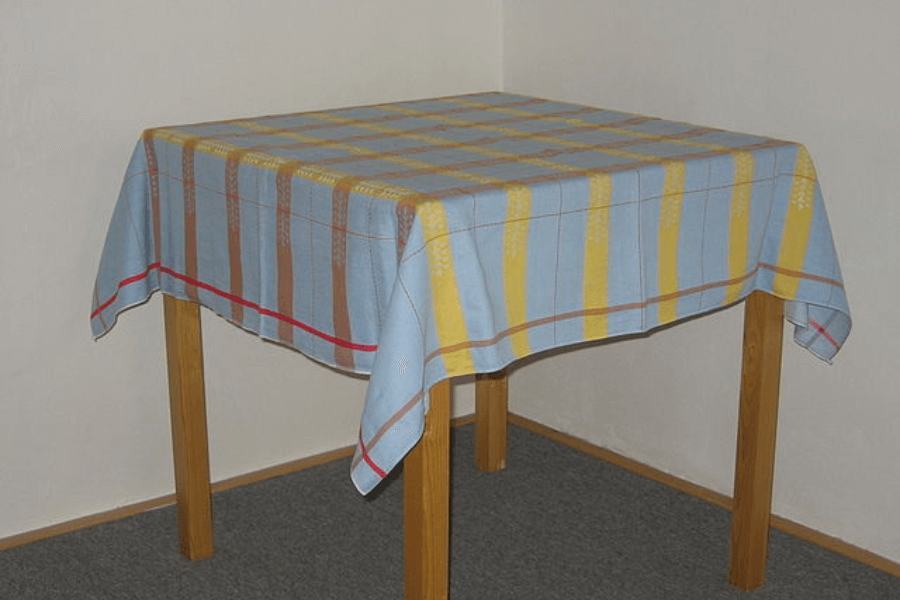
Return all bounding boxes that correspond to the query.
[772,146,816,300]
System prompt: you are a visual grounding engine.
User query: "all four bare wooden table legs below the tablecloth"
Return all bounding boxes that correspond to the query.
[164,292,784,600]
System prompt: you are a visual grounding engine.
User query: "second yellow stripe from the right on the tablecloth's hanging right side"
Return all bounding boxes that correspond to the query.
[725,152,755,304]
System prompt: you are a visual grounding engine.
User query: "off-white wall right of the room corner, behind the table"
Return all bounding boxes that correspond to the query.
[503,0,900,561]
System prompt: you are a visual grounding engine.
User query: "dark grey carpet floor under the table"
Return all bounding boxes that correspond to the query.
[0,426,900,600]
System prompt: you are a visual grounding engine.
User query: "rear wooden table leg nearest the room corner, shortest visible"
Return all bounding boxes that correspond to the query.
[475,369,508,473]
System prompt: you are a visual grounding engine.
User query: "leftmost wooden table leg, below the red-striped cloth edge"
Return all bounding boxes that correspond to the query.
[163,295,213,560]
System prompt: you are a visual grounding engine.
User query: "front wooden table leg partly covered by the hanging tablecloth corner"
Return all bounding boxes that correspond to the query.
[403,380,450,600]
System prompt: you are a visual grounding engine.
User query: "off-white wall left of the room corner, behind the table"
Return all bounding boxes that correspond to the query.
[0,0,500,538]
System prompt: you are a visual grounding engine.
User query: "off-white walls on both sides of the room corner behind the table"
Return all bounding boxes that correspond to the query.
[8,0,900,560]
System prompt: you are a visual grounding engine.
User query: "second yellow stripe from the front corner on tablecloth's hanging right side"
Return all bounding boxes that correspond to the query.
[503,185,531,357]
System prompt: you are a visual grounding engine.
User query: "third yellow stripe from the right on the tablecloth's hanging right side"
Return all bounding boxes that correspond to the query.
[657,162,685,325]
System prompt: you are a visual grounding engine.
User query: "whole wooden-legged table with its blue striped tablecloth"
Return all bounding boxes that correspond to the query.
[91,92,851,598]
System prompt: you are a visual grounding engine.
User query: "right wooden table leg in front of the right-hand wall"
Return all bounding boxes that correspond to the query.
[728,292,784,591]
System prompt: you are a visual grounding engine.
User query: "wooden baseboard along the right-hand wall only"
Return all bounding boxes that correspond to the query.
[508,413,900,577]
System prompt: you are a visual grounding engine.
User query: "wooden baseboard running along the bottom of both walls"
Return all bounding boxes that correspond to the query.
[0,413,900,577]
